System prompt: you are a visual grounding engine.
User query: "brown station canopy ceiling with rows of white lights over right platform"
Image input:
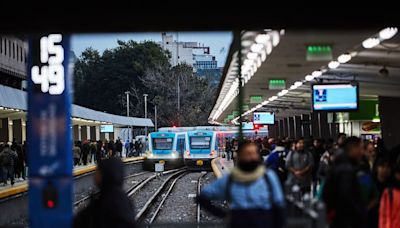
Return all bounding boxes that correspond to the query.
[209,28,400,124]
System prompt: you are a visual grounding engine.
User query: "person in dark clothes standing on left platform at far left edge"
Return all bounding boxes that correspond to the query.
[0,144,18,186]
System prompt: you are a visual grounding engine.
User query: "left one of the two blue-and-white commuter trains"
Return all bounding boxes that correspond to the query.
[143,132,189,171]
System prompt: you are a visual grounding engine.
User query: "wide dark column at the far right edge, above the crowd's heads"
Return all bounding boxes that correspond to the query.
[378,97,400,150]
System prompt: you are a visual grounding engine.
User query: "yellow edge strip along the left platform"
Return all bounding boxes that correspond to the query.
[0,157,145,199]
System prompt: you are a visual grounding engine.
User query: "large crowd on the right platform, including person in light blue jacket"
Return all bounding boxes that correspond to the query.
[200,133,400,228]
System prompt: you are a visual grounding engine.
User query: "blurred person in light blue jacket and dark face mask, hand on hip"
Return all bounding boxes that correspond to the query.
[197,142,285,228]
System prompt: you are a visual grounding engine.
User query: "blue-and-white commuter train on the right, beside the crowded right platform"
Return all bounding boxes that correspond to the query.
[184,130,219,170]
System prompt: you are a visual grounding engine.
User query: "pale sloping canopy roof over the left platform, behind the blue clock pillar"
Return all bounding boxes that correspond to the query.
[0,85,154,127]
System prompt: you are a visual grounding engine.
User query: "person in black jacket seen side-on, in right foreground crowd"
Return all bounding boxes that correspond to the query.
[322,136,367,228]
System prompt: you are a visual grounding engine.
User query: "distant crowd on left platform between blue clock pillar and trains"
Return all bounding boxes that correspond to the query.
[72,138,147,166]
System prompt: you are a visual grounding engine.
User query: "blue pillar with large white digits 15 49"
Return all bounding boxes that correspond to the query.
[27,34,73,228]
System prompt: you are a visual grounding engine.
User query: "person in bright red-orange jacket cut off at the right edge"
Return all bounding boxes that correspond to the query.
[379,164,400,228]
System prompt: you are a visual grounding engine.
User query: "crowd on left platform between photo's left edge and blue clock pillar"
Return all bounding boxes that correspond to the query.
[0,140,28,186]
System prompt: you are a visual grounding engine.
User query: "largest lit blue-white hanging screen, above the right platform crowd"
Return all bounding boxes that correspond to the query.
[312,84,358,112]
